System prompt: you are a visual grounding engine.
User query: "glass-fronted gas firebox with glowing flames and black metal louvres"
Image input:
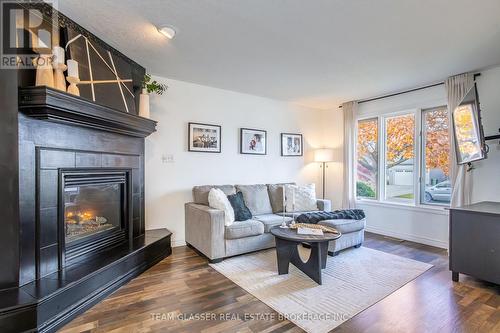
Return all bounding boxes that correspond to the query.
[59,169,131,266]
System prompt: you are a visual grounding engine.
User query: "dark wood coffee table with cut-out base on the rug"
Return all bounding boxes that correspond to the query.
[271,226,342,284]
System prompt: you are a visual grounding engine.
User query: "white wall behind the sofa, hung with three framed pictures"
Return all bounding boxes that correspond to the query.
[145,78,336,245]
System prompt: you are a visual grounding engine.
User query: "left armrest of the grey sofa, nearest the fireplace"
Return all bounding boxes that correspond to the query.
[184,202,225,260]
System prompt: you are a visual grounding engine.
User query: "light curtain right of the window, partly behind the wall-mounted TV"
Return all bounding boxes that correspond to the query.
[445,73,474,207]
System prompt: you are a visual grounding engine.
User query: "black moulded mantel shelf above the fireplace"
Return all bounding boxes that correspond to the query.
[19,87,156,138]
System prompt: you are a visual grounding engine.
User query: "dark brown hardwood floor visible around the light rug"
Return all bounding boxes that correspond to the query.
[61,233,500,333]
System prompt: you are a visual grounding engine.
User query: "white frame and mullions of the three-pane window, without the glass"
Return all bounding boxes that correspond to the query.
[353,105,451,210]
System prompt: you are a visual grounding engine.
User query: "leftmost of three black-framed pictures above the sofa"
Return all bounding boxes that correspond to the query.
[188,123,221,153]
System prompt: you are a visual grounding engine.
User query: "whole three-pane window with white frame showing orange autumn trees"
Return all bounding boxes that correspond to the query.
[355,106,452,206]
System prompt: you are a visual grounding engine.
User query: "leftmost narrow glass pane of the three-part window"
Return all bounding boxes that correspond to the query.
[356,118,378,199]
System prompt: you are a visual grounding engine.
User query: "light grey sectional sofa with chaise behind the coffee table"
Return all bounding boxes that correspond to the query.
[185,184,365,262]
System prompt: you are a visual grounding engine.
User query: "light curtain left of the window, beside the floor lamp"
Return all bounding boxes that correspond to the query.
[342,101,358,209]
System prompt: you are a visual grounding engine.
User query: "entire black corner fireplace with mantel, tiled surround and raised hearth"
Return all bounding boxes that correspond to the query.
[0,87,172,332]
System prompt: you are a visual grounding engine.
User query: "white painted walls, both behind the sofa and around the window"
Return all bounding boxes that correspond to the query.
[146,67,500,248]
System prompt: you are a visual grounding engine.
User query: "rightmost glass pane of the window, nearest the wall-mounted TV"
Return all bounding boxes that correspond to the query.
[420,107,451,204]
